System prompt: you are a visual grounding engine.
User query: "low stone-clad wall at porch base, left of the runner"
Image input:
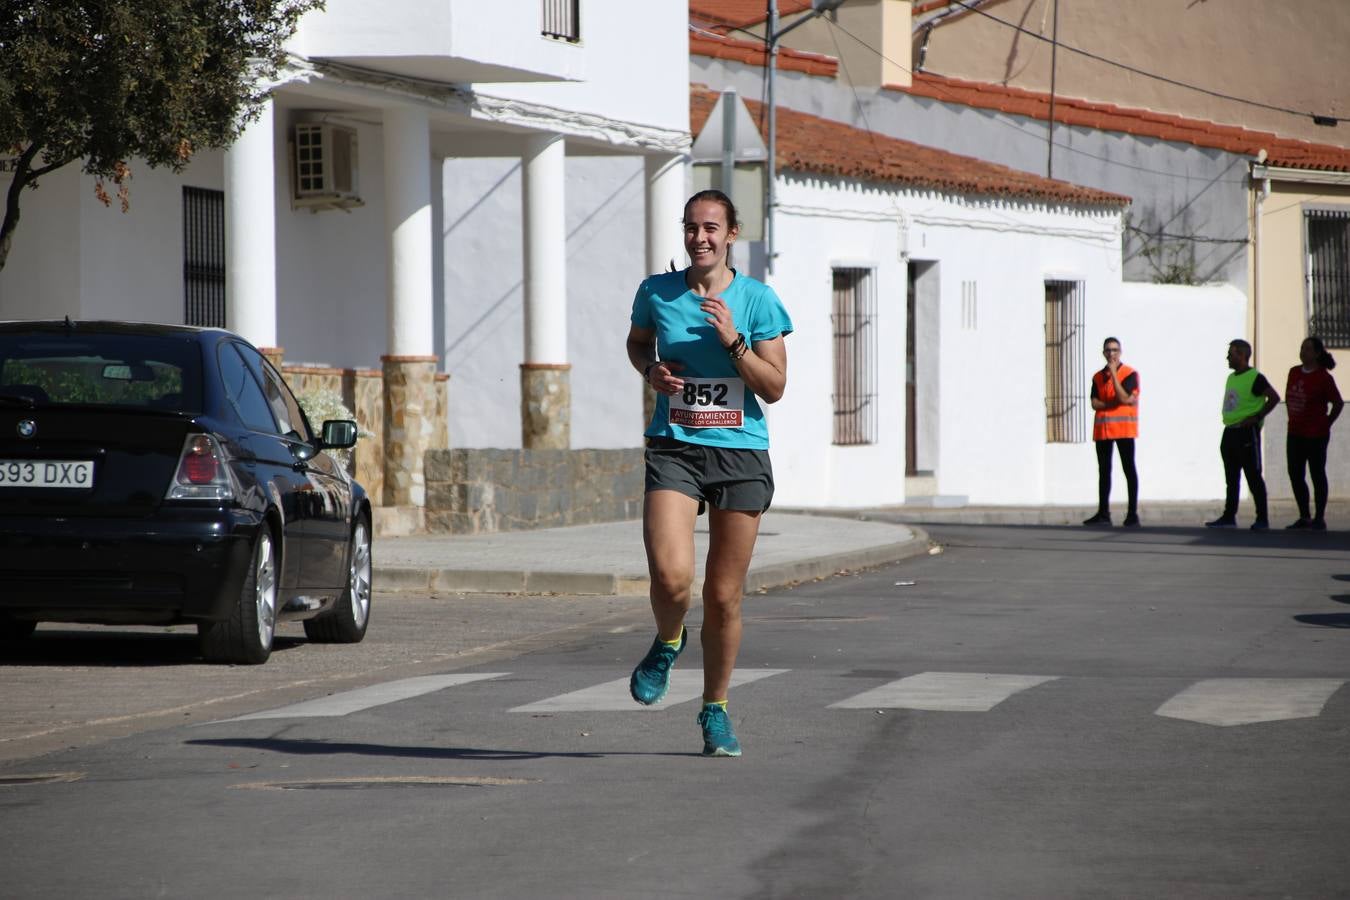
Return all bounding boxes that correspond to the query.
[425,448,643,534]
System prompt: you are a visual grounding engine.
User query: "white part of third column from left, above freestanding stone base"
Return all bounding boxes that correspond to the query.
[522,135,567,363]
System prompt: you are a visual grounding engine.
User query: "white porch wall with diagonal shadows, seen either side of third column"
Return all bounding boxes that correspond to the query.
[443,157,650,448]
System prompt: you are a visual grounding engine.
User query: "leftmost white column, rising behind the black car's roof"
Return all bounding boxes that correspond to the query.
[225,100,277,347]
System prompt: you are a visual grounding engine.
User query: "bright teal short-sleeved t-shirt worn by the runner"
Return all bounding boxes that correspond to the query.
[632,271,792,449]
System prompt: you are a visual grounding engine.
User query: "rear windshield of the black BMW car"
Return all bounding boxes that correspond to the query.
[0,332,201,413]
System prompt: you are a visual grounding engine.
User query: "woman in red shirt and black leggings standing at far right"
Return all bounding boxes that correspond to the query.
[1284,337,1345,532]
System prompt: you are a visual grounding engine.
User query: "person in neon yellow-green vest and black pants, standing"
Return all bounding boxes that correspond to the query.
[1206,339,1280,532]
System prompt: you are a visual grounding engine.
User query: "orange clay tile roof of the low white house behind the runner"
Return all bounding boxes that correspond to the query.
[690,86,1130,206]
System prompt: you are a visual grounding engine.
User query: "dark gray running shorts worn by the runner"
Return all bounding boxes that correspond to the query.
[645,437,774,513]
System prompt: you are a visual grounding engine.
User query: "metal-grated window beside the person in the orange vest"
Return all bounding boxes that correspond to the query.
[1045,281,1088,444]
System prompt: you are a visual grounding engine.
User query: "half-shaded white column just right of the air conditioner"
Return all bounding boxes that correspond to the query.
[385,108,435,356]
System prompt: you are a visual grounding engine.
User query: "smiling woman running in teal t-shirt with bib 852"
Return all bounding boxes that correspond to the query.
[628,190,792,757]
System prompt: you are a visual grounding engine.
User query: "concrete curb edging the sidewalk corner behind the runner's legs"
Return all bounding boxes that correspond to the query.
[374,525,930,596]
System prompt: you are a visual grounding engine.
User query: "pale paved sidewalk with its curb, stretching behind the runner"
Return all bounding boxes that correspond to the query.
[373,499,1350,595]
